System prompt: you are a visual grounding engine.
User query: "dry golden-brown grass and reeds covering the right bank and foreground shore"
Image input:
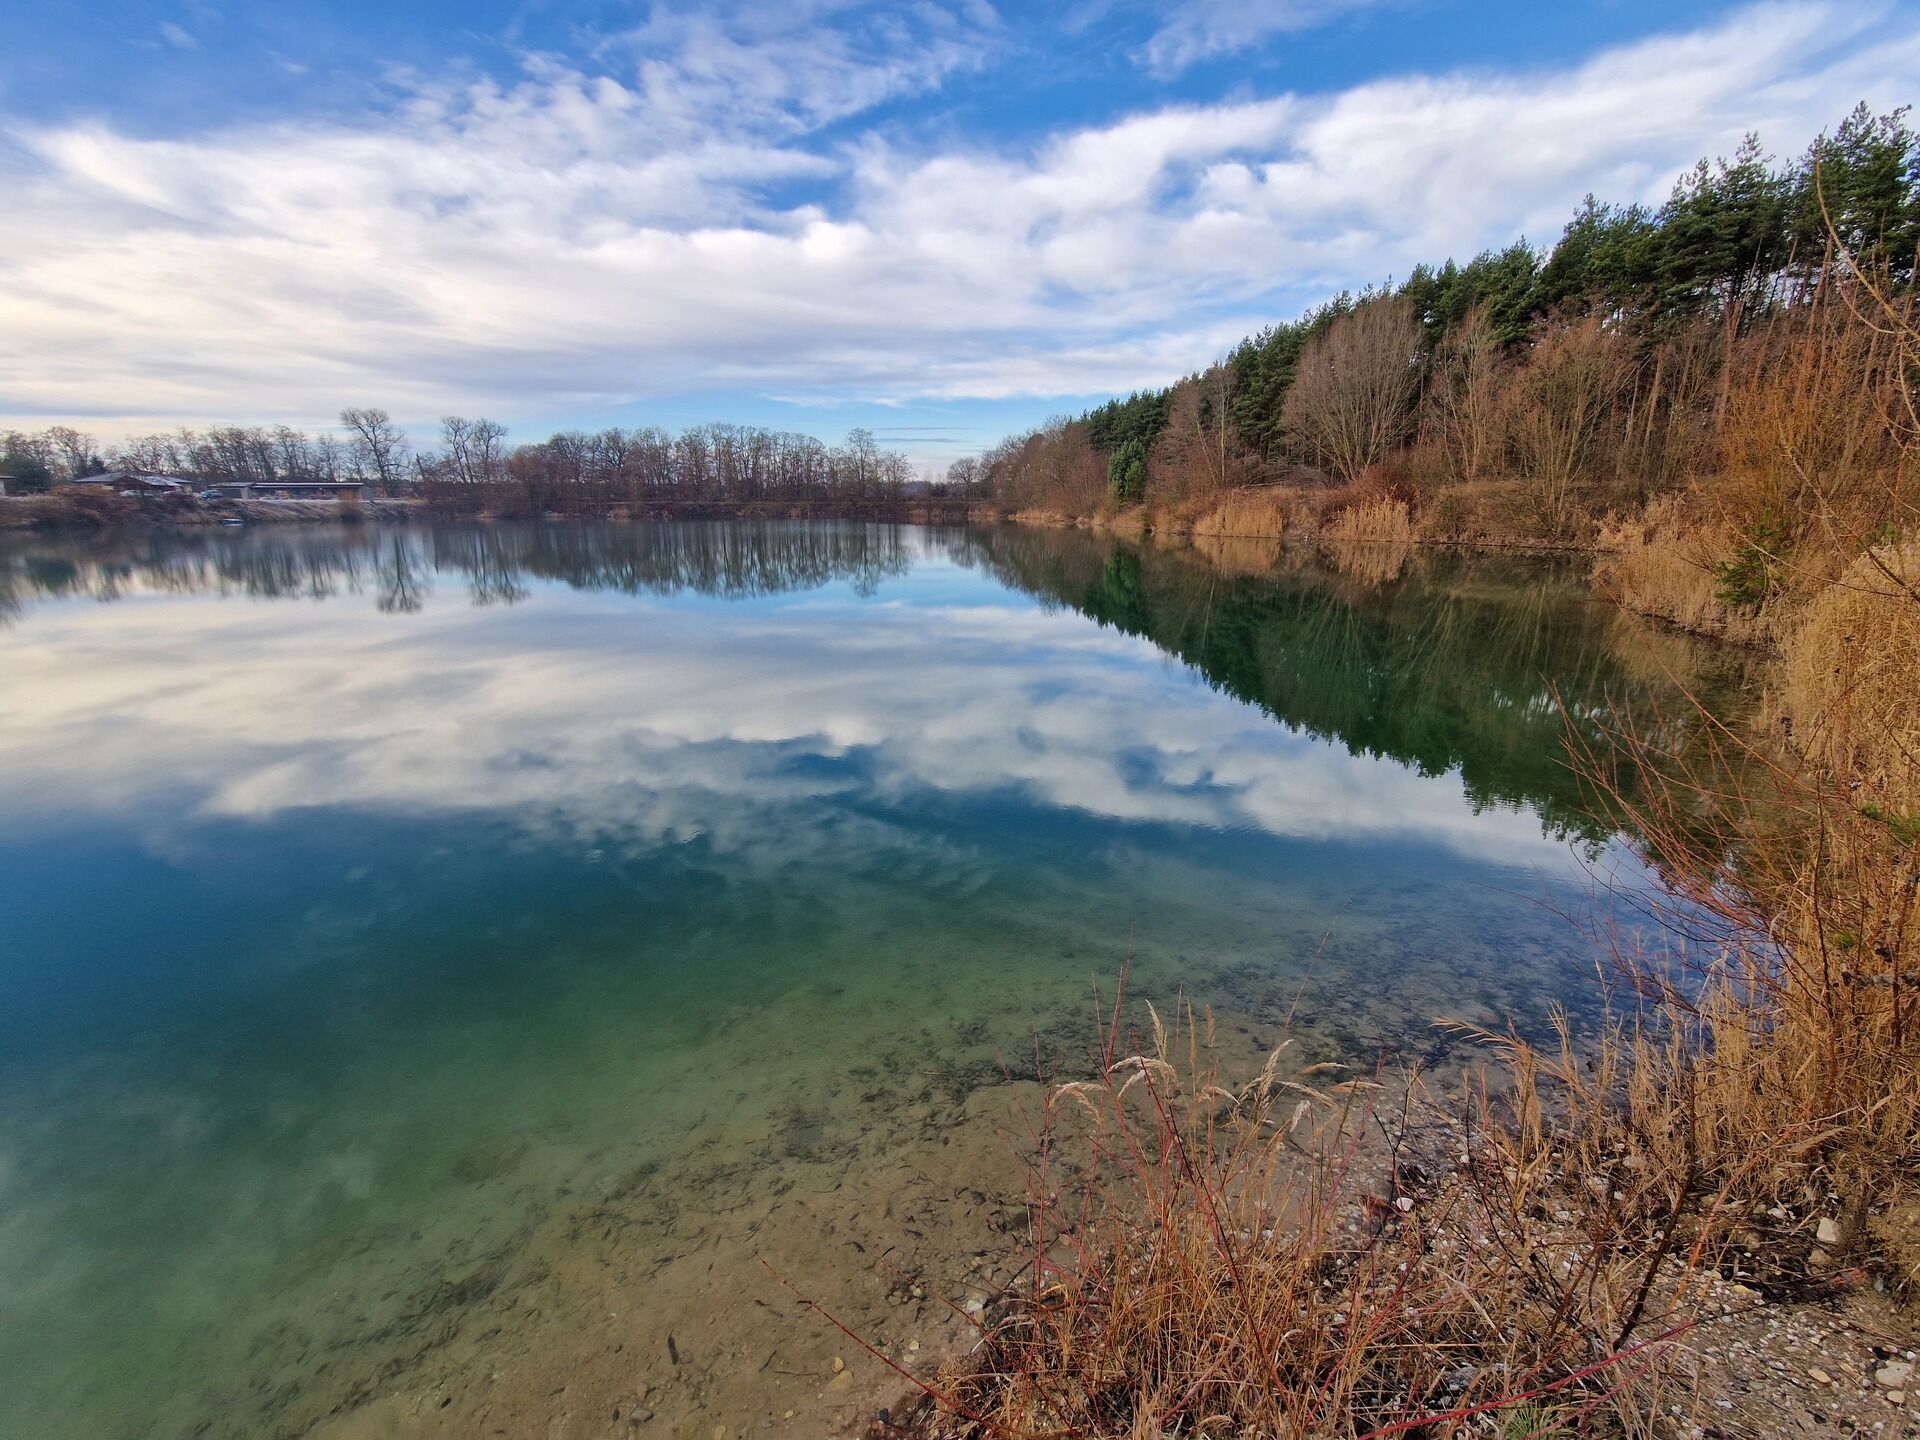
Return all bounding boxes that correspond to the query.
[860,276,1920,1438]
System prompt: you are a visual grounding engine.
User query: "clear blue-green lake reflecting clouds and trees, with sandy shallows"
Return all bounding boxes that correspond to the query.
[0,522,1732,1440]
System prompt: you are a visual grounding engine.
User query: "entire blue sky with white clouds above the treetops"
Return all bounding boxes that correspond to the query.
[0,0,1920,463]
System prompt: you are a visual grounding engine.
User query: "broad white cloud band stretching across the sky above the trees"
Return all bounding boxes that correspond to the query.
[0,4,1920,428]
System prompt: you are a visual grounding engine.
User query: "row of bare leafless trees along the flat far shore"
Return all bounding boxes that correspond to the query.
[0,407,945,515]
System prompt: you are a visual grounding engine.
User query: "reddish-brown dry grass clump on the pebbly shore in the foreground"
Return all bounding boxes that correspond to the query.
[887,1010,1743,1440]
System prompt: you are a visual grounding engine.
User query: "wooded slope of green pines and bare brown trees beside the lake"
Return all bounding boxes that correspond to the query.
[966,96,1920,541]
